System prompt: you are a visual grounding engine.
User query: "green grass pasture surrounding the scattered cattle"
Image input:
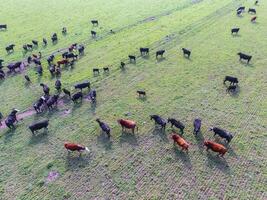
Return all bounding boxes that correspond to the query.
[0,0,267,200]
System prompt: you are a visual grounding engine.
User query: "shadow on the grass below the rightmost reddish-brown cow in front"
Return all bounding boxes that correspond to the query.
[207,151,230,174]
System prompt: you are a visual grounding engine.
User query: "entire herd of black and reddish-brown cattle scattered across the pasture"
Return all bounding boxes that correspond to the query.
[0,1,258,156]
